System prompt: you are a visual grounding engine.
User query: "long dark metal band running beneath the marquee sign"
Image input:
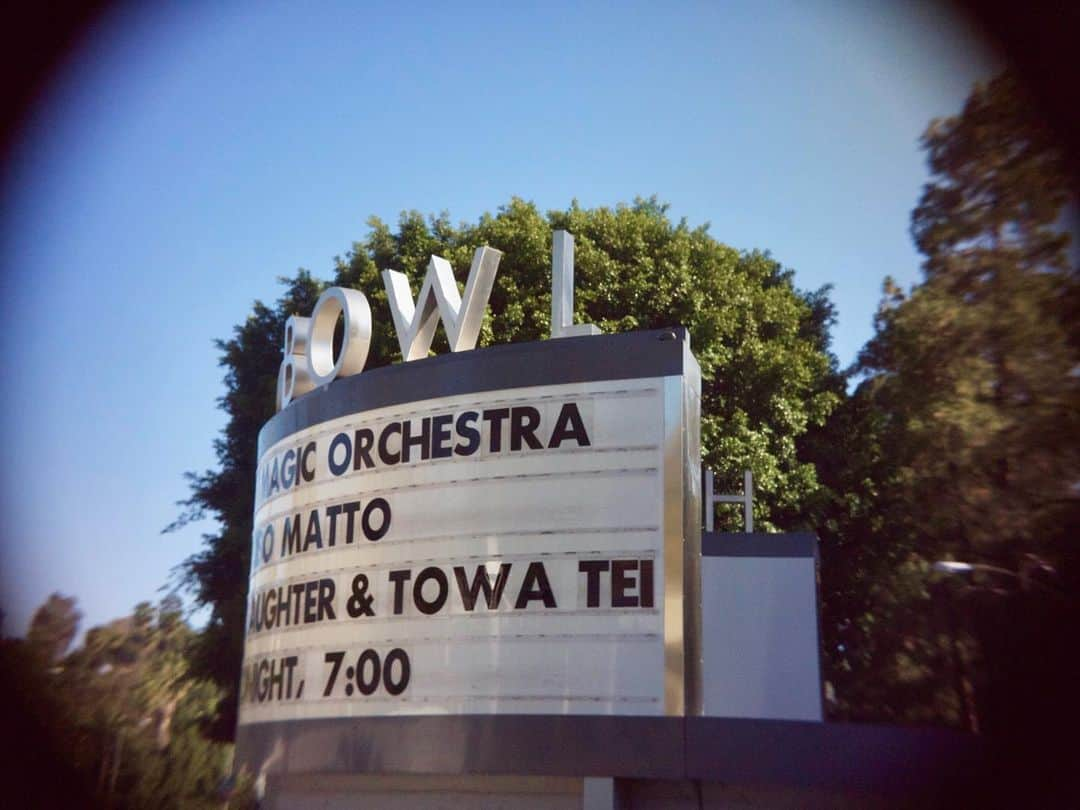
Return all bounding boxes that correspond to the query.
[235,715,989,793]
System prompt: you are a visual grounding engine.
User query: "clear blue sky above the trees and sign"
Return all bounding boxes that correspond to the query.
[0,2,995,633]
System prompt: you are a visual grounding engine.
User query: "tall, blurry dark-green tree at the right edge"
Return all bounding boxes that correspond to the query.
[810,75,1080,729]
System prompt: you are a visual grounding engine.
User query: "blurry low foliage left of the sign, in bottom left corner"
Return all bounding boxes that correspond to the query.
[0,594,239,808]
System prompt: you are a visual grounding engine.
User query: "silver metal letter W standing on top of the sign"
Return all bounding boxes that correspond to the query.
[382,247,502,361]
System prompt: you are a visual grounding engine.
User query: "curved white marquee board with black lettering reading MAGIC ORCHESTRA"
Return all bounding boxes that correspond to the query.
[240,333,700,725]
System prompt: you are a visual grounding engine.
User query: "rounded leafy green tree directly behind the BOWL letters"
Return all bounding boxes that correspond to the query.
[179,199,839,733]
